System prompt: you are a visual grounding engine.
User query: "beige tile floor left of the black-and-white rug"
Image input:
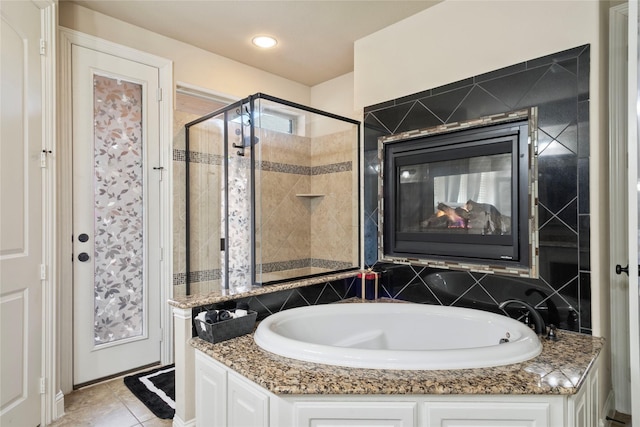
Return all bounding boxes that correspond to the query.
[51,377,173,427]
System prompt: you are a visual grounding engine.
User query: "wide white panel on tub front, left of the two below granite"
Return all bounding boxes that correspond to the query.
[294,402,417,427]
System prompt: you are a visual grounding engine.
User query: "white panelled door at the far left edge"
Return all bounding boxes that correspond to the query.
[0,1,45,427]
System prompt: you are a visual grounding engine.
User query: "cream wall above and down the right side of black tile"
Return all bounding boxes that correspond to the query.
[354,0,610,414]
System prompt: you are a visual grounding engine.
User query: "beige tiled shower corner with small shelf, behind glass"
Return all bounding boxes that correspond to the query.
[256,130,358,274]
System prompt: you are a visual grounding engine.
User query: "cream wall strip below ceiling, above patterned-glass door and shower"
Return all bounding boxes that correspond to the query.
[59,2,310,105]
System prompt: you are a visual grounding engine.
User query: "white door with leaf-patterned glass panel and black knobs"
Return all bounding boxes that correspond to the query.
[72,46,162,386]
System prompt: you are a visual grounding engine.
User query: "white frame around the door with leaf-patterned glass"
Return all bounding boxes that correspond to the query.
[58,27,173,393]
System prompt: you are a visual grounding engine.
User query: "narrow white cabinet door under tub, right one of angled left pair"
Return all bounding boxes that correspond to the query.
[229,373,269,427]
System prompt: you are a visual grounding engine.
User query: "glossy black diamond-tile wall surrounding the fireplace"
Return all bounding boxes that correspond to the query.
[364,45,591,333]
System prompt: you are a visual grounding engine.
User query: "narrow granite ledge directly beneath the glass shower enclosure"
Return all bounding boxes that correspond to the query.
[168,270,360,309]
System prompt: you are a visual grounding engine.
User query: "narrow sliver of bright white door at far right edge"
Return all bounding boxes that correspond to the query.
[627,1,640,419]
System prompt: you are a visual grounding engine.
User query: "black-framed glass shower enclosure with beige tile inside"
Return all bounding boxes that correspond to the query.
[185,93,360,295]
